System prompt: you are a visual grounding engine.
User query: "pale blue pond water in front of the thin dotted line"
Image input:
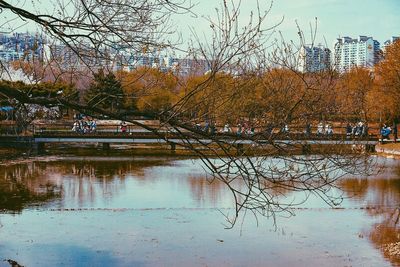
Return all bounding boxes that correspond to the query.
[0,209,390,267]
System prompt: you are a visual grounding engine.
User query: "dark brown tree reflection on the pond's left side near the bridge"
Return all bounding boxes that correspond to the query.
[0,159,171,210]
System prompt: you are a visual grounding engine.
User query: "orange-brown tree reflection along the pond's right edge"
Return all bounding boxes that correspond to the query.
[340,167,400,266]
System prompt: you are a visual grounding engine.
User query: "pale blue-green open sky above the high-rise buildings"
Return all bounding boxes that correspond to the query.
[180,0,400,48]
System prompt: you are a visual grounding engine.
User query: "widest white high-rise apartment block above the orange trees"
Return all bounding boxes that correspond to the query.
[333,36,381,72]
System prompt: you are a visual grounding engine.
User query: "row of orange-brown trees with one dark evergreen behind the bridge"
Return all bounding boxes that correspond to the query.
[1,41,400,125]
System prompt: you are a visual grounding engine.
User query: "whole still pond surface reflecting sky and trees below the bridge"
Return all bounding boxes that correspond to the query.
[0,156,400,266]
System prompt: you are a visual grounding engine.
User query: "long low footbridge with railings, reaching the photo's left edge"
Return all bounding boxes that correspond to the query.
[0,125,382,152]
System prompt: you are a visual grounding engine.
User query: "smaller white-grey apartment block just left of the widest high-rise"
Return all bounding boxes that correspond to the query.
[298,44,331,72]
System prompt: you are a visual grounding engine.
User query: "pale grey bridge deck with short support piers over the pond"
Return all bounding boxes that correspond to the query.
[32,132,379,151]
